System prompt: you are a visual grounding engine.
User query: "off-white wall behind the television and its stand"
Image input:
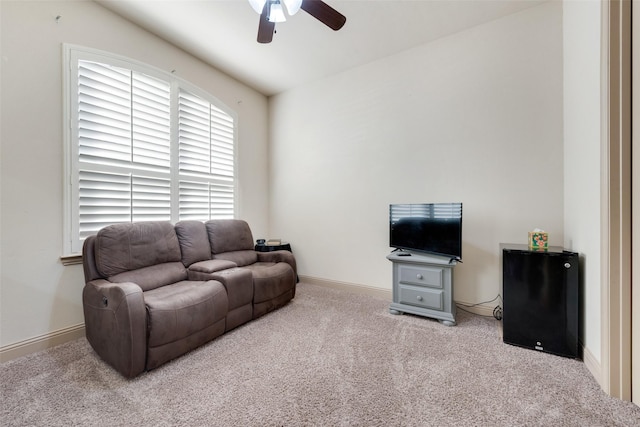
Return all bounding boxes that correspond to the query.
[270,2,564,302]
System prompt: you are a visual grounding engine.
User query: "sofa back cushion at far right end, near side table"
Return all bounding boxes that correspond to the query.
[205,219,254,255]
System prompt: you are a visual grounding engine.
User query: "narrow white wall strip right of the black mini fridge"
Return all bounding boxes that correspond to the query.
[563,0,601,363]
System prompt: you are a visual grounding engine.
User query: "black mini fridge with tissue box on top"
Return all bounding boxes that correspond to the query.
[501,244,580,358]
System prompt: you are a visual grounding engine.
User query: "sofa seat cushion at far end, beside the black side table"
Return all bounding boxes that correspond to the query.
[243,262,296,304]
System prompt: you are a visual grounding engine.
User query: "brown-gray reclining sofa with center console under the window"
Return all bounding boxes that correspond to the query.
[82,220,297,378]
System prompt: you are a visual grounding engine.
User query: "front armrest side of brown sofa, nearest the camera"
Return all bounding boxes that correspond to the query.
[82,279,147,378]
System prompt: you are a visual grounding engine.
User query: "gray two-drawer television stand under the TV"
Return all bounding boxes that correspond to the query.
[387,252,457,326]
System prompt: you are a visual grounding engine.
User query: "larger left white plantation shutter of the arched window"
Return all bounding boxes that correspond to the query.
[78,61,171,239]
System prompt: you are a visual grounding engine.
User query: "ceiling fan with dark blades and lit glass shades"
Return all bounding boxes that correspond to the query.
[249,0,347,43]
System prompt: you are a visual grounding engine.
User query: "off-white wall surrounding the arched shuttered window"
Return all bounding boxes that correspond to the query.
[0,1,268,348]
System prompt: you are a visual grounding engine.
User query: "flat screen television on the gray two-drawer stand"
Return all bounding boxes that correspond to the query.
[389,203,462,260]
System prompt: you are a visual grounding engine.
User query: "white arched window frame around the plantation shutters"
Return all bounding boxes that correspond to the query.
[62,44,239,256]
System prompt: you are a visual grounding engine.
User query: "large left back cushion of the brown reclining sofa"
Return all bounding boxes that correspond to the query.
[94,221,181,277]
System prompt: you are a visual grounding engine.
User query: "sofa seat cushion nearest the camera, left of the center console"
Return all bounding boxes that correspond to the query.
[144,280,228,347]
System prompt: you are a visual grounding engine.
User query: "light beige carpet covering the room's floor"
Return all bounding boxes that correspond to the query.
[0,283,640,426]
